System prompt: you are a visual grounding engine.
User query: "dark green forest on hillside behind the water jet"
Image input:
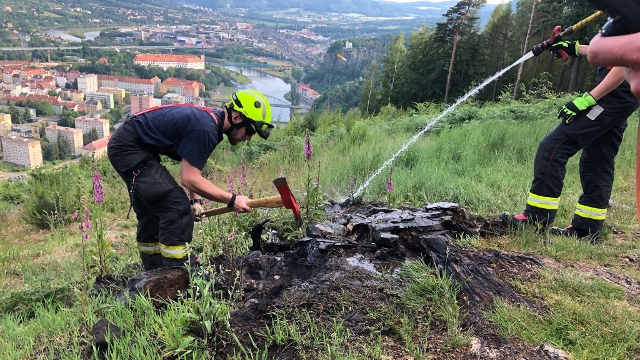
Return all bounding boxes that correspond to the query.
[303,0,606,114]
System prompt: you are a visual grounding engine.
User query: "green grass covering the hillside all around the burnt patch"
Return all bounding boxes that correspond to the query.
[0,98,640,359]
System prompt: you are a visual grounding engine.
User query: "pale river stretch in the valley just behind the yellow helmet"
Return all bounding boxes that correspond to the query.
[224,66,291,122]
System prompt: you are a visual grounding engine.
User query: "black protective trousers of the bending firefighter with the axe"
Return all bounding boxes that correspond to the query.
[107,119,194,270]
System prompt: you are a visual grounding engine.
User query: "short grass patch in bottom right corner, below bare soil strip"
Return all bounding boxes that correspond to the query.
[489,270,640,359]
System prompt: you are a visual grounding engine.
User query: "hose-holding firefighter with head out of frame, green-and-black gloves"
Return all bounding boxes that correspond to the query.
[500,41,639,243]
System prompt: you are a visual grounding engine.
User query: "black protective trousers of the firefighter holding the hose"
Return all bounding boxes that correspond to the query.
[524,94,638,233]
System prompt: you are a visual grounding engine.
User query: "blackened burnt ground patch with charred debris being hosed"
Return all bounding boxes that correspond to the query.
[206,203,566,359]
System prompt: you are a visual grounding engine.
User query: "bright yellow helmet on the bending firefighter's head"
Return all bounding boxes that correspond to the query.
[229,89,273,139]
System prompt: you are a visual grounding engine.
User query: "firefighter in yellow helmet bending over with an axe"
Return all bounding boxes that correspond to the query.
[107,90,273,270]
